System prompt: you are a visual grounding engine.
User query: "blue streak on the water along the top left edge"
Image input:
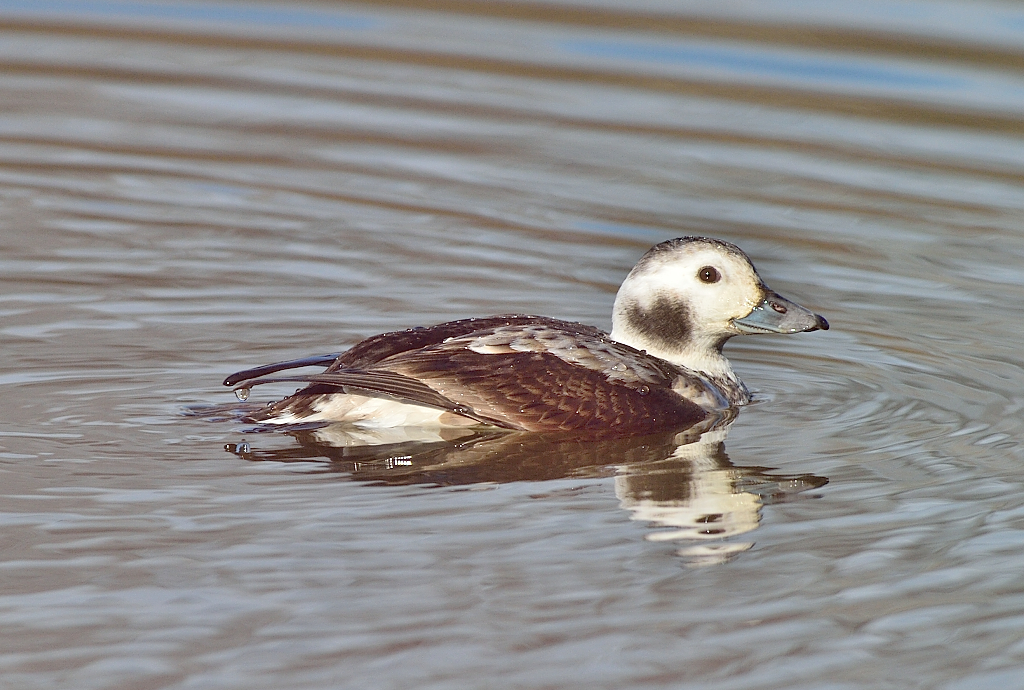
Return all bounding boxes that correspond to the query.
[0,0,380,31]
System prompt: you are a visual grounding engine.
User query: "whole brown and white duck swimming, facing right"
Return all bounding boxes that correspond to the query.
[223,236,828,435]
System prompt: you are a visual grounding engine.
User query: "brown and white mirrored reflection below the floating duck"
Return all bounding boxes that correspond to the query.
[227,415,828,565]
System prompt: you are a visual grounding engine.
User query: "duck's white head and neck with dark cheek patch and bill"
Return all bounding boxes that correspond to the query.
[611,238,828,394]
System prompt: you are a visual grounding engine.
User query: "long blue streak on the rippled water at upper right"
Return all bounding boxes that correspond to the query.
[560,40,964,88]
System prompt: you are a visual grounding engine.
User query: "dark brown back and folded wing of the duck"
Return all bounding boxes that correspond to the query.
[228,315,707,434]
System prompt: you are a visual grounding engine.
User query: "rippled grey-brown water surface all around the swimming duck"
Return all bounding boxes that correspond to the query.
[6,0,1024,690]
